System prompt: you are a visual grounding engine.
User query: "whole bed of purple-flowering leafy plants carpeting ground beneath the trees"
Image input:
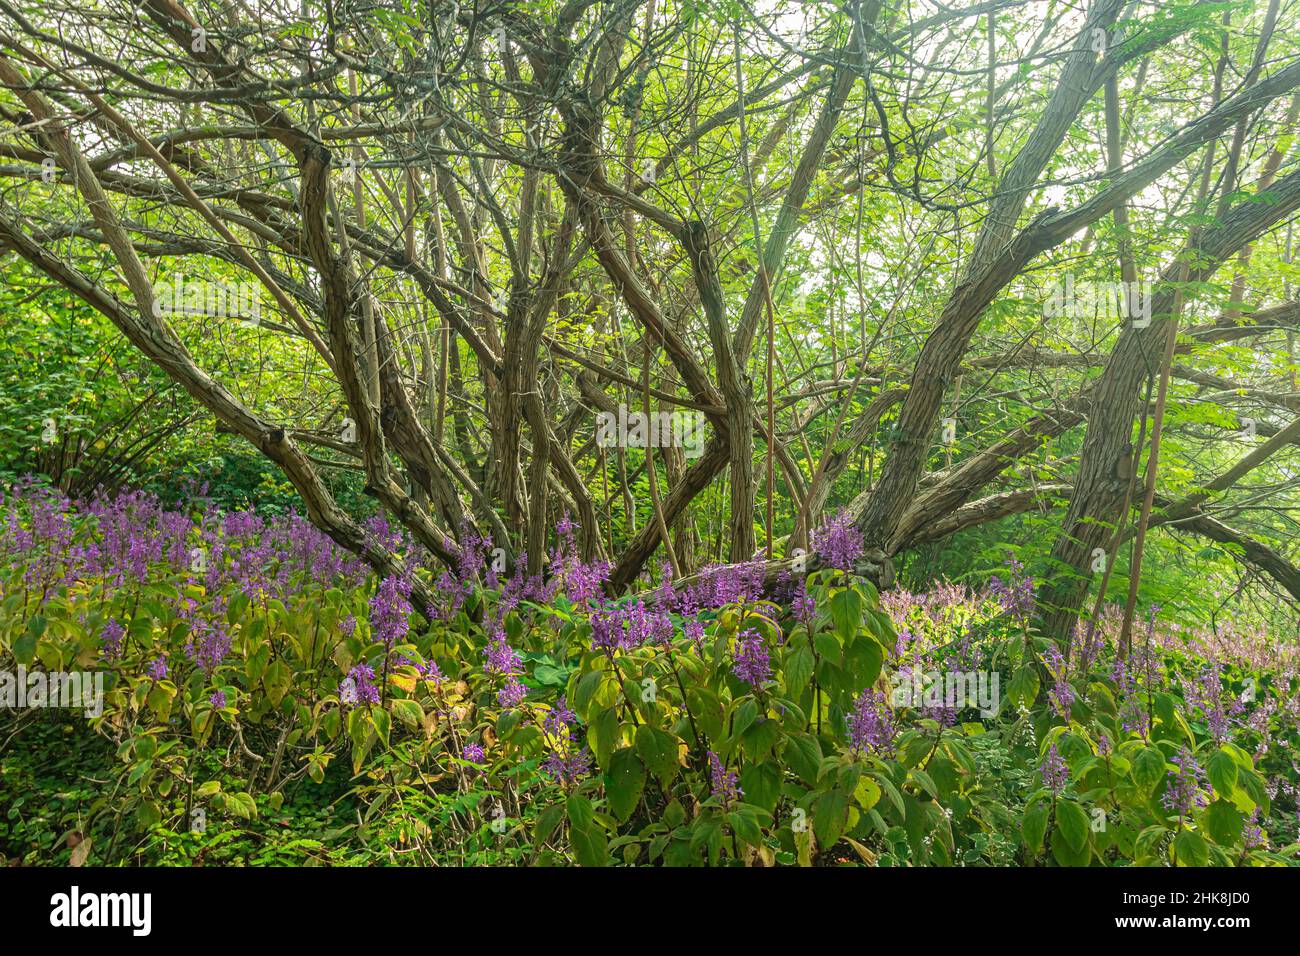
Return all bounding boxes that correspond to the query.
[0,484,1300,866]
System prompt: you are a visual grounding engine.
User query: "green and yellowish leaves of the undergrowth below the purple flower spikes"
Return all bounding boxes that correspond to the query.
[0,504,1297,866]
